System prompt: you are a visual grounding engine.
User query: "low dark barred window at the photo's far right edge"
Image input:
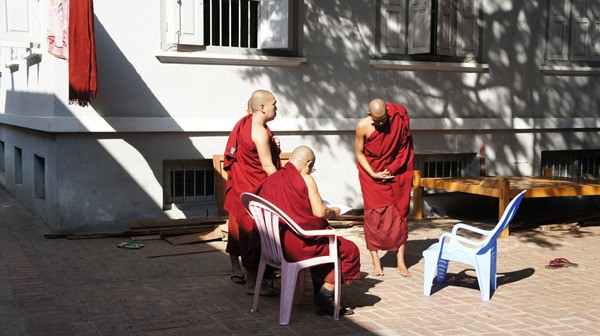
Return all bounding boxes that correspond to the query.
[541,150,600,178]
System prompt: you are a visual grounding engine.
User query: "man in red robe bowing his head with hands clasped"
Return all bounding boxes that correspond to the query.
[355,98,414,277]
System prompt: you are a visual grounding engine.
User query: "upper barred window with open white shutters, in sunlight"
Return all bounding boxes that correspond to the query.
[166,0,294,50]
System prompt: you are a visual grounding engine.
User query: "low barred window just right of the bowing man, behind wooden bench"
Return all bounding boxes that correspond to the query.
[414,153,476,177]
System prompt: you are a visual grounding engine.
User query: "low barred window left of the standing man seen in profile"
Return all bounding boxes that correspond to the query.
[164,160,216,207]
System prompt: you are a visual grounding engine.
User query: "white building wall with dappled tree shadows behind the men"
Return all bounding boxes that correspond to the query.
[0,0,600,231]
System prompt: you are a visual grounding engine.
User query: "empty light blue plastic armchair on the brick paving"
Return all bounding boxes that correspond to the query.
[423,190,527,301]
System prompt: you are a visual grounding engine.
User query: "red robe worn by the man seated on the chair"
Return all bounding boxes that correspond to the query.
[255,162,360,284]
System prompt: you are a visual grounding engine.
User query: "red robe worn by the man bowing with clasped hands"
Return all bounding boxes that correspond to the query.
[358,103,414,251]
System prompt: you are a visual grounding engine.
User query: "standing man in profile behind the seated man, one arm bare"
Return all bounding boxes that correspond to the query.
[223,90,281,296]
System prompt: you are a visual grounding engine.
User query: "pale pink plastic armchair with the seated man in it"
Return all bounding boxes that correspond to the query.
[241,193,341,325]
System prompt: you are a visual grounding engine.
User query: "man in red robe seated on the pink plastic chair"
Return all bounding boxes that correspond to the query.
[255,146,360,315]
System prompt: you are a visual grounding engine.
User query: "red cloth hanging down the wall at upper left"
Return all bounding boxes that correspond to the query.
[69,0,98,106]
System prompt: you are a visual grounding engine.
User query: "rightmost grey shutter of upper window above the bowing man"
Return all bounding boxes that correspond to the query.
[456,0,479,57]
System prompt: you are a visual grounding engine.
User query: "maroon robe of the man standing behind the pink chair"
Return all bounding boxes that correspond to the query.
[223,114,281,269]
